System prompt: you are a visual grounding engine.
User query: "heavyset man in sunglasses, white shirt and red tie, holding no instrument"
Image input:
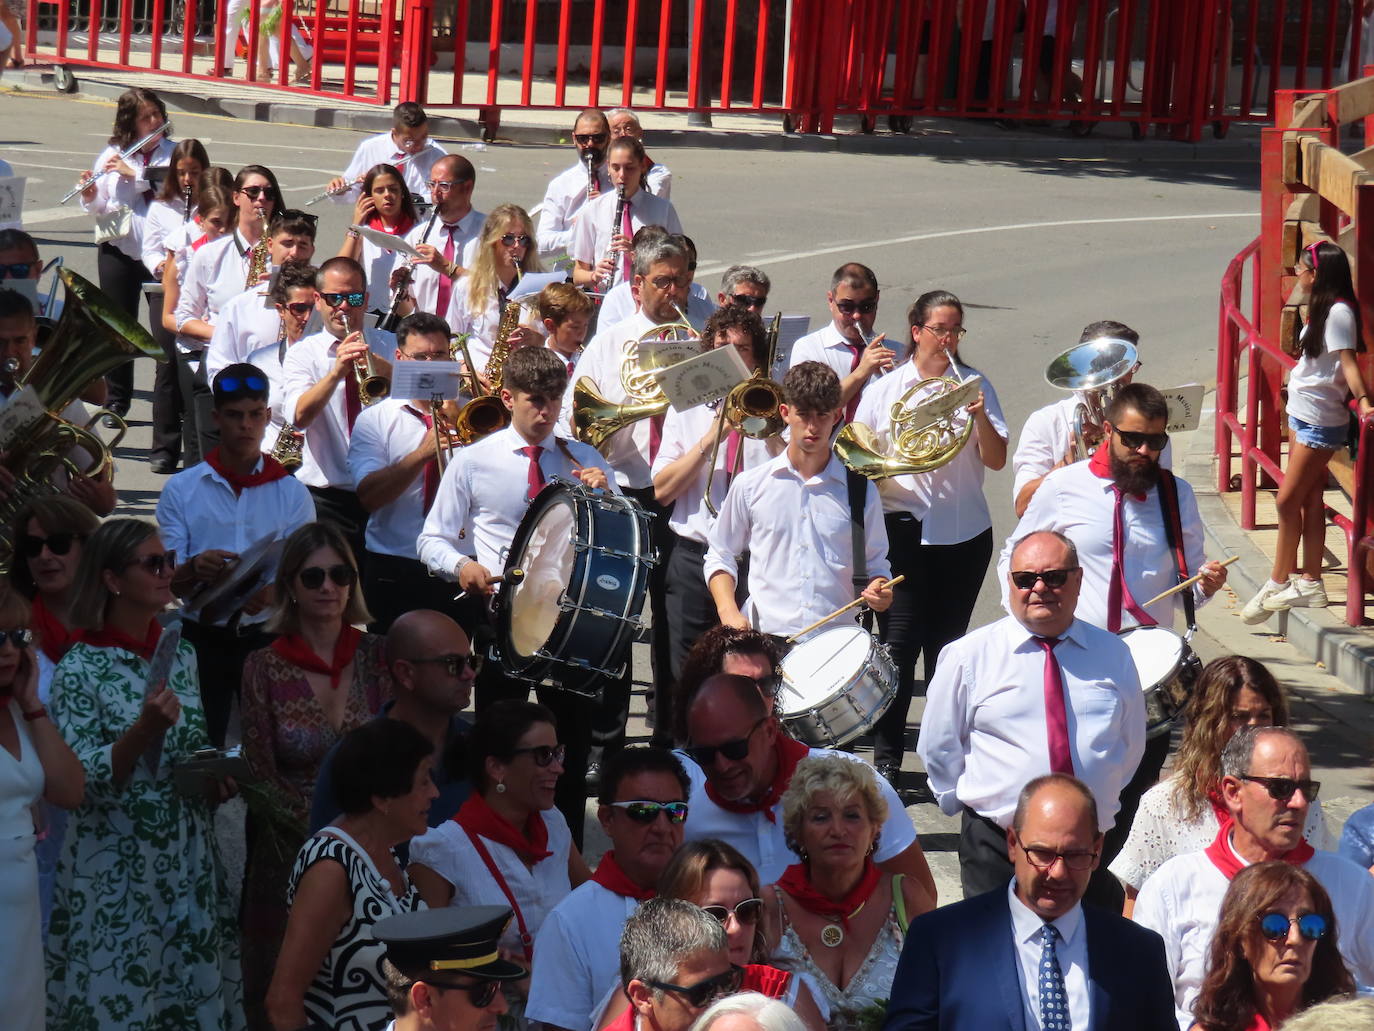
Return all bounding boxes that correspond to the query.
[916,529,1145,911]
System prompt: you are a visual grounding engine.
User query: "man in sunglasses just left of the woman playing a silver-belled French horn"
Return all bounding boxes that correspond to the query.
[791,261,896,422]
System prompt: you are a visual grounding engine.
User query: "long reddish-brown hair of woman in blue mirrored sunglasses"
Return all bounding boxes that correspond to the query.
[1193,859,1355,1031]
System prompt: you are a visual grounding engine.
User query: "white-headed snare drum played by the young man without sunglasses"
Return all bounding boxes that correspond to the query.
[778,625,897,748]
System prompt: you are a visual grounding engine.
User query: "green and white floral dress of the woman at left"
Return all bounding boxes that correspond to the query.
[48,641,243,1031]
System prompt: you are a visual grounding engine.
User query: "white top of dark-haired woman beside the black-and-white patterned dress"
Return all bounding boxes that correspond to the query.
[411,808,573,955]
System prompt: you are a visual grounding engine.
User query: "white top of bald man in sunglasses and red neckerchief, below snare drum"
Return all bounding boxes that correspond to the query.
[675,748,916,884]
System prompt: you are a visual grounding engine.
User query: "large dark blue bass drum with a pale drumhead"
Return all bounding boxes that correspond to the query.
[496,477,654,697]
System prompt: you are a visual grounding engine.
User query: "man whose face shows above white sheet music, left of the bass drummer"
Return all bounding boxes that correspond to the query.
[348,312,456,634]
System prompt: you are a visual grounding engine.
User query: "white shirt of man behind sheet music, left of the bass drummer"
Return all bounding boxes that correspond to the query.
[348,397,434,558]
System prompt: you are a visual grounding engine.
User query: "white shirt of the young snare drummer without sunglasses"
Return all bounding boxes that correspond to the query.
[703,451,892,636]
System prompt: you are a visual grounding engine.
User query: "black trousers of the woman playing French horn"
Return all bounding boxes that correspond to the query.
[872,513,992,766]
